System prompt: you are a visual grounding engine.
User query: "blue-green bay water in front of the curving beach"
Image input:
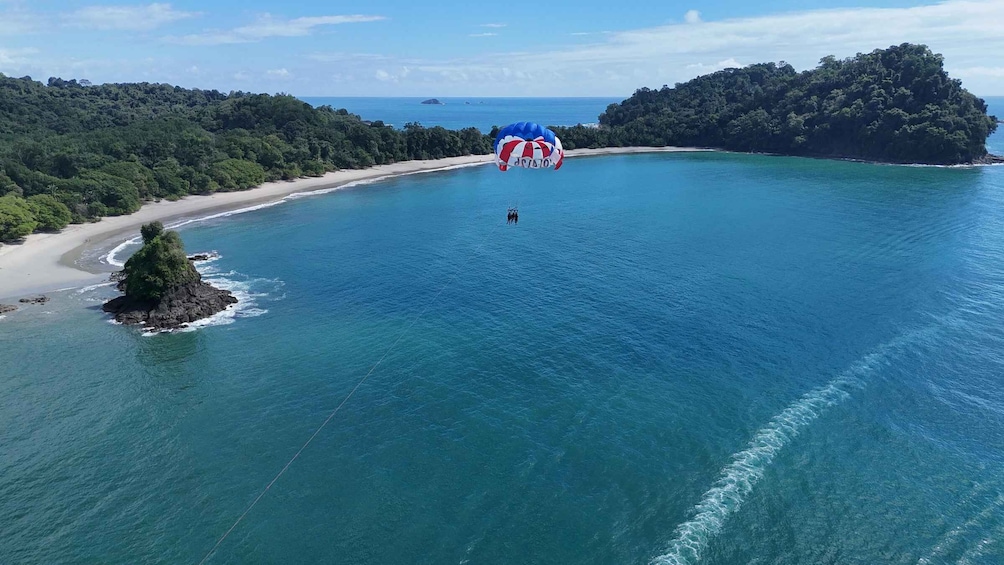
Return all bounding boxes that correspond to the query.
[0,98,1004,565]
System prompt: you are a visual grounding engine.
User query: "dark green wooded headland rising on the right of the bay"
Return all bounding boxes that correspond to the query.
[556,44,997,165]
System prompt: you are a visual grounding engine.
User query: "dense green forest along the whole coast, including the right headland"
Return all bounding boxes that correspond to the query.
[0,44,997,241]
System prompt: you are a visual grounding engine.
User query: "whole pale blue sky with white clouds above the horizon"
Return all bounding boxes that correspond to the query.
[0,0,1004,96]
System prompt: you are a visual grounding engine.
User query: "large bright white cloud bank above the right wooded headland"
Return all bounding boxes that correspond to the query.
[459,0,1004,94]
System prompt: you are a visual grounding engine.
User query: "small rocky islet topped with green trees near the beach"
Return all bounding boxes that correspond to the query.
[102,222,237,330]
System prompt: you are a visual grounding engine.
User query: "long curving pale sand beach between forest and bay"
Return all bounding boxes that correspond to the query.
[0,148,706,299]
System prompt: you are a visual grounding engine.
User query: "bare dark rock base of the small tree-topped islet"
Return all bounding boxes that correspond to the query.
[102,281,237,330]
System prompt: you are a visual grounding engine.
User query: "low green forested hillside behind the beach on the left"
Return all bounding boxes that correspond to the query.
[0,75,491,241]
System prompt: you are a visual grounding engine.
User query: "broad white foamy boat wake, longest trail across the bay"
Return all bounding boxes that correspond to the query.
[651,332,916,565]
